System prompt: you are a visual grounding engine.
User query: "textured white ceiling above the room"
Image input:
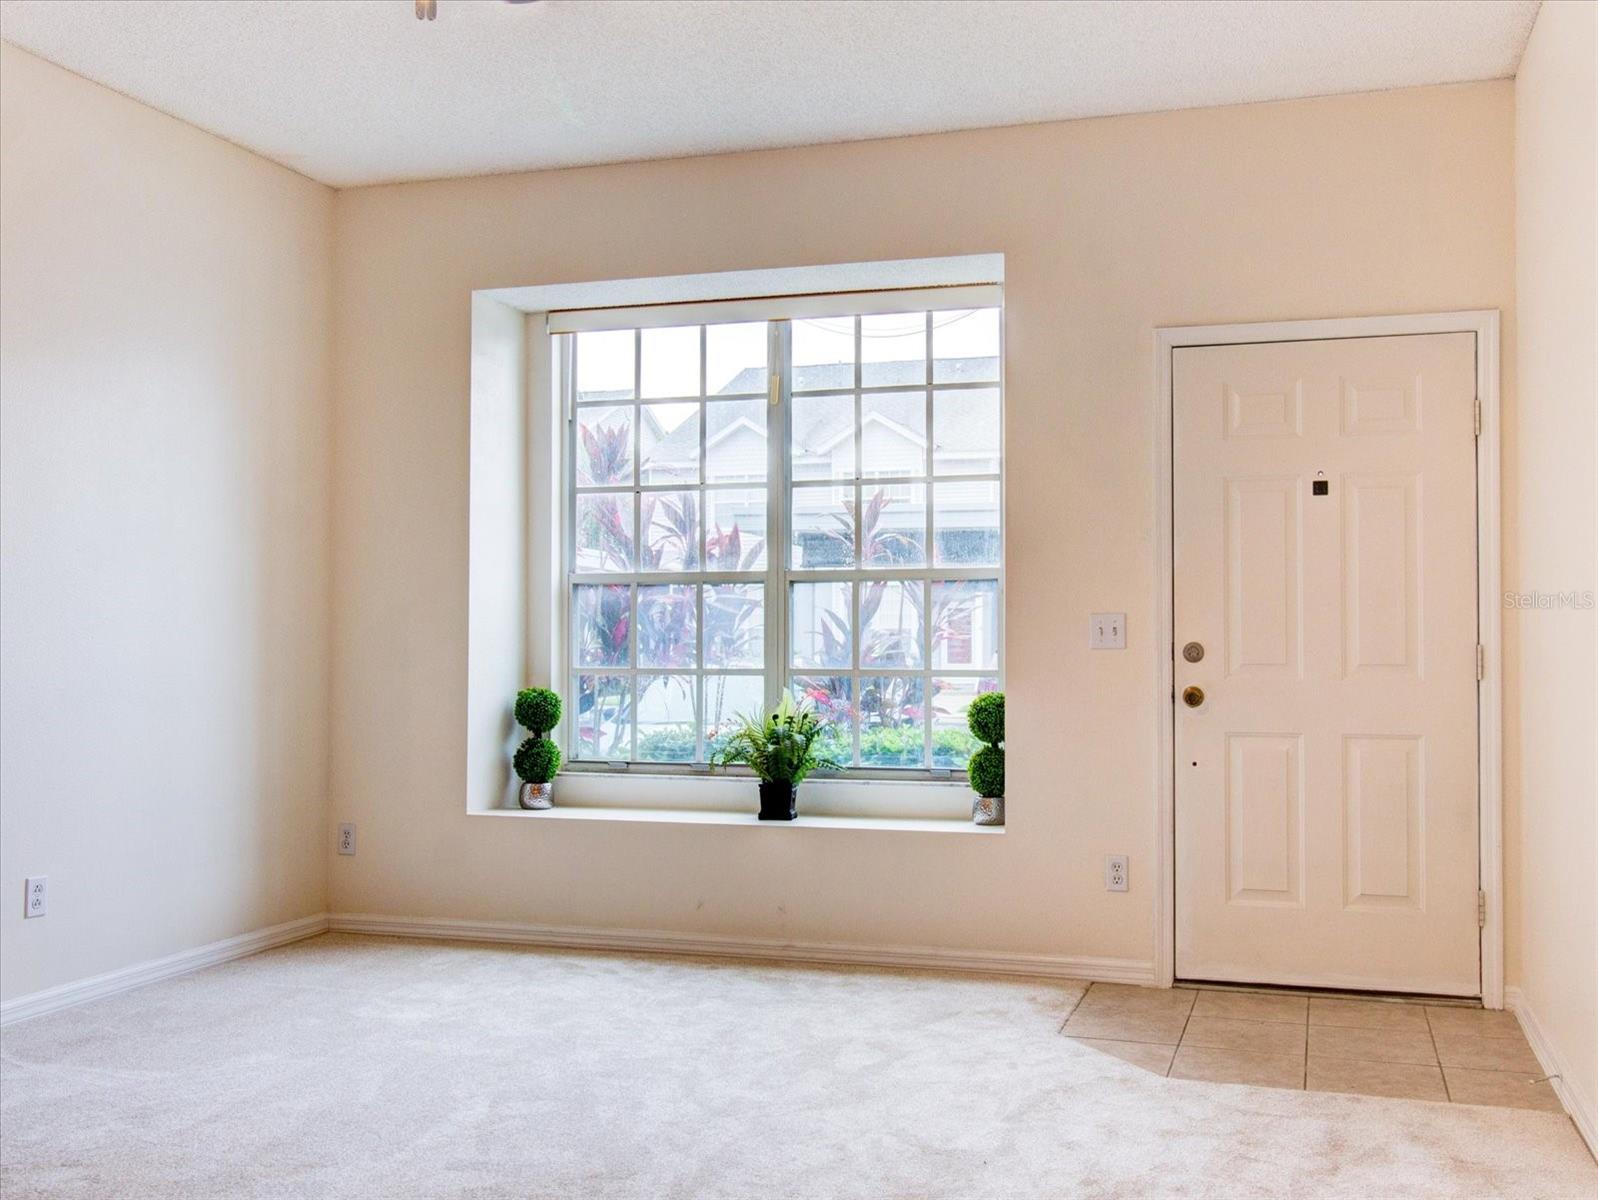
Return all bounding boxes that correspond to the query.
[0,0,1537,187]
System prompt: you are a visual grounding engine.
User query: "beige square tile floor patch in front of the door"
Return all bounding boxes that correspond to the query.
[1061,983,1563,1112]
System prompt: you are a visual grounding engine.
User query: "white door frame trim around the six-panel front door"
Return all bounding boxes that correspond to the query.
[1154,308,1504,1008]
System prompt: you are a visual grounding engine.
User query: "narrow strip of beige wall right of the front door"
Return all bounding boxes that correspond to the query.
[1504,3,1598,1138]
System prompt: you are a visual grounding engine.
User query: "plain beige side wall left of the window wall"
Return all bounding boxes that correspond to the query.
[0,45,332,997]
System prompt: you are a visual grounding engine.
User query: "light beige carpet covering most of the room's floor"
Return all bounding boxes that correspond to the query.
[0,935,1598,1200]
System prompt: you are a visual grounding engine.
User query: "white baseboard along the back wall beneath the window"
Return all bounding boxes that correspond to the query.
[328,912,1154,987]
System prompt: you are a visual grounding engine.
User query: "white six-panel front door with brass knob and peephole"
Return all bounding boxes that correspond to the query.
[1171,332,1481,995]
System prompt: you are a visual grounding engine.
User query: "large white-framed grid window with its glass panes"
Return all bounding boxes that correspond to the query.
[551,289,1004,775]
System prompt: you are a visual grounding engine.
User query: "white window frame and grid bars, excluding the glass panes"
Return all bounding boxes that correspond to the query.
[547,284,1008,783]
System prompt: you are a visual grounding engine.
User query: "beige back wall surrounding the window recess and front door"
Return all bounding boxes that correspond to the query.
[329,83,1518,964]
